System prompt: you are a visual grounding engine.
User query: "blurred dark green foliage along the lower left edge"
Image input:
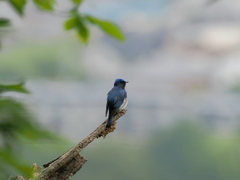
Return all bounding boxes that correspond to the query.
[0,83,63,179]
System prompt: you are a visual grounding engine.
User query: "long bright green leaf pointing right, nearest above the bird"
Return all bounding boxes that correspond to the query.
[84,15,125,41]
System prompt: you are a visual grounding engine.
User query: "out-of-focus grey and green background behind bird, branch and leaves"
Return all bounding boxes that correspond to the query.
[0,0,240,180]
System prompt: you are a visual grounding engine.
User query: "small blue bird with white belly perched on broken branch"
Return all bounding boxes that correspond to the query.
[106,79,128,128]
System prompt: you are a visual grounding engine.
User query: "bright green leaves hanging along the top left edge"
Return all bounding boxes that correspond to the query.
[0,0,125,44]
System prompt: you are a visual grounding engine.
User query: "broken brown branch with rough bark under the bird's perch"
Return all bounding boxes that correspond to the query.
[14,109,127,180]
